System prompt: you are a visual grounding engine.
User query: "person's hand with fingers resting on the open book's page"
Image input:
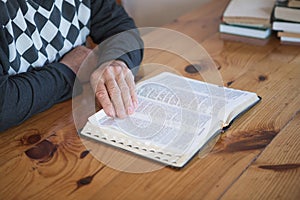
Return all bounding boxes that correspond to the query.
[90,60,138,118]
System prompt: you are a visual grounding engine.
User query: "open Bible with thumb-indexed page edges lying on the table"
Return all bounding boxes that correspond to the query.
[81,72,260,167]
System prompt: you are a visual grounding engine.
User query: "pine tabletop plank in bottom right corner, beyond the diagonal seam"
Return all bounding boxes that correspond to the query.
[222,112,300,199]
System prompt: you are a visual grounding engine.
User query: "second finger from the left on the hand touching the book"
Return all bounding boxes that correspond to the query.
[105,78,126,118]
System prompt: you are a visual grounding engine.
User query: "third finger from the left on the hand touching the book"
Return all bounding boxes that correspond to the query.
[117,73,134,115]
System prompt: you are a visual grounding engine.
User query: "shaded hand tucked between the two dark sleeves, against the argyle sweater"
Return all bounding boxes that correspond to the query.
[60,46,92,74]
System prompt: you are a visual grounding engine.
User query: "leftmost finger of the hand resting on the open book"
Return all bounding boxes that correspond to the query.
[95,83,116,117]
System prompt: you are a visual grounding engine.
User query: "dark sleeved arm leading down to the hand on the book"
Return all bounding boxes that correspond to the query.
[91,0,143,74]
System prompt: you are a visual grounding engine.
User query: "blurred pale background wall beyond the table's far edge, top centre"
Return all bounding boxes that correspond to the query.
[122,0,209,27]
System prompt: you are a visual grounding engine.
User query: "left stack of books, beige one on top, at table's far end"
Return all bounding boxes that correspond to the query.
[219,0,276,39]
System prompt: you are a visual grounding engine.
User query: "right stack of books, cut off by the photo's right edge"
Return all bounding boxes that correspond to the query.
[272,0,300,44]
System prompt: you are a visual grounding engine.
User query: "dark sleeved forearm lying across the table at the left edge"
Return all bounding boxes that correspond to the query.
[0,63,81,131]
